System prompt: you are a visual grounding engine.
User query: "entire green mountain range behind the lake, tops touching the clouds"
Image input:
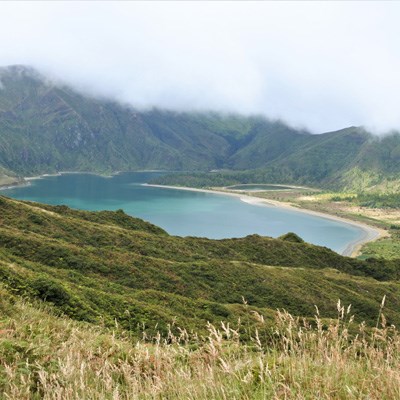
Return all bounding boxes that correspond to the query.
[0,66,400,192]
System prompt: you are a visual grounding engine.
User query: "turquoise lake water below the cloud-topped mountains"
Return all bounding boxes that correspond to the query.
[1,172,363,253]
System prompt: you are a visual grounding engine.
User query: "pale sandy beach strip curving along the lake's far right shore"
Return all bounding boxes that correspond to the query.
[142,183,388,258]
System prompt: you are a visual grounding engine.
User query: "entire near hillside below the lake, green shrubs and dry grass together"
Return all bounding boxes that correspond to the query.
[0,196,400,400]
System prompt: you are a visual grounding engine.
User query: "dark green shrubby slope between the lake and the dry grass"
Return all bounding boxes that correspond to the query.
[0,197,400,333]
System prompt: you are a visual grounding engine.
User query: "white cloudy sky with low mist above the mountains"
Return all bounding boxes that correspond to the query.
[0,1,400,133]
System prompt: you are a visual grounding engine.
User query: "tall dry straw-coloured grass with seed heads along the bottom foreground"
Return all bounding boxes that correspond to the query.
[0,301,400,400]
